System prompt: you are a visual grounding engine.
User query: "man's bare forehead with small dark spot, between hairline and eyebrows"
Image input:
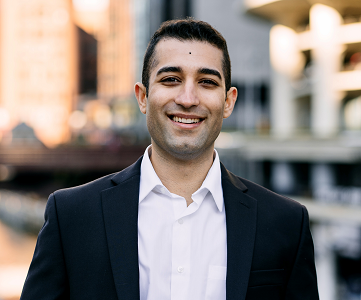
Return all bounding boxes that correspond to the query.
[151,38,223,76]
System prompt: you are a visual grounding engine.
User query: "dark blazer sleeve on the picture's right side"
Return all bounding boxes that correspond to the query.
[285,206,319,300]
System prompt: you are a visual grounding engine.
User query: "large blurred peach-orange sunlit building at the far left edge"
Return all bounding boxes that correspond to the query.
[0,0,78,146]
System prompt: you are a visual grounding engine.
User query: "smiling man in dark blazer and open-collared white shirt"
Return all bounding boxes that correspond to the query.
[21,19,318,300]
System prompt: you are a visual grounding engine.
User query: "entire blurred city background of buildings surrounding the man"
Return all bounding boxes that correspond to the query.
[0,0,361,300]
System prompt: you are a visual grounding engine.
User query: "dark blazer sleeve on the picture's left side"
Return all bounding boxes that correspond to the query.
[20,194,69,300]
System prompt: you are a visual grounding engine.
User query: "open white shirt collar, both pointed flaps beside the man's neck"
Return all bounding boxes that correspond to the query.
[139,145,224,212]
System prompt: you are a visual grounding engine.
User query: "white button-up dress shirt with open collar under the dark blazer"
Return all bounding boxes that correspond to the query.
[138,146,227,300]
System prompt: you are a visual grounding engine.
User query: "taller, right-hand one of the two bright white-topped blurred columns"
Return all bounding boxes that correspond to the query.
[310,4,342,138]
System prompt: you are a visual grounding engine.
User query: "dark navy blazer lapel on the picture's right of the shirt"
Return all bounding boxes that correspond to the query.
[221,165,257,300]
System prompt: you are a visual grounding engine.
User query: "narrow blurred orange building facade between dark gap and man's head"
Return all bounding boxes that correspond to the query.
[97,0,136,100]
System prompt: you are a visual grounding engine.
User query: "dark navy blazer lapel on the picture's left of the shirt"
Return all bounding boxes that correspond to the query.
[102,159,141,300]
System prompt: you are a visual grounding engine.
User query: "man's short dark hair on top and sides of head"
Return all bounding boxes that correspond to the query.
[142,18,231,96]
